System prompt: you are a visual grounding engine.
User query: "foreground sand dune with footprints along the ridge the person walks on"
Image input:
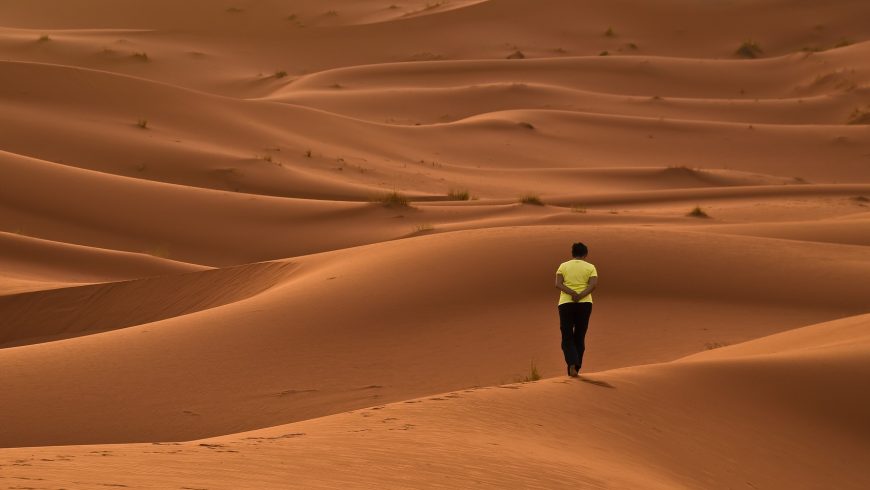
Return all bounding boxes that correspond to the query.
[0,315,870,489]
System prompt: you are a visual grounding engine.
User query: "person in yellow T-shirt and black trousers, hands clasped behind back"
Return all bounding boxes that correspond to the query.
[556,242,598,377]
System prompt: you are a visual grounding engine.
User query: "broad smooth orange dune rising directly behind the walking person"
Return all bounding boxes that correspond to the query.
[0,226,870,446]
